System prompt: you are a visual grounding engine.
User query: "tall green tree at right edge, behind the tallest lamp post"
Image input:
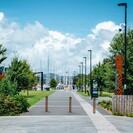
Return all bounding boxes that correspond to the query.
[110,30,133,89]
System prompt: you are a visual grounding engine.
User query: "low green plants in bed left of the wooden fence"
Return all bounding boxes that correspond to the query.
[98,100,112,111]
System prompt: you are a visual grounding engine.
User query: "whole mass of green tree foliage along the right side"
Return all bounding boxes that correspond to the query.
[88,30,133,92]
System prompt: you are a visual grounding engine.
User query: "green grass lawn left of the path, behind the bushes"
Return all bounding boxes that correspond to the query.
[20,90,54,106]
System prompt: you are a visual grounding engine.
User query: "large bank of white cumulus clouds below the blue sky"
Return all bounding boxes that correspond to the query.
[0,13,119,74]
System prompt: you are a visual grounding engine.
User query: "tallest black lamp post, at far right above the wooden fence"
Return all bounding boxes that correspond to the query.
[118,3,127,89]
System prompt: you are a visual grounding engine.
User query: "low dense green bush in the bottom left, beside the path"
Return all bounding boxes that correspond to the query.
[0,95,29,116]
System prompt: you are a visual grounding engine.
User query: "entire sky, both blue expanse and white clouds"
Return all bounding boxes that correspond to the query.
[0,0,133,75]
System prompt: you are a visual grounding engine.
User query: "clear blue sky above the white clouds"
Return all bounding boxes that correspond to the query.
[0,0,133,37]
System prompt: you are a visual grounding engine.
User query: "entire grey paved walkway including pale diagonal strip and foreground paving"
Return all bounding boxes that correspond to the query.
[0,91,133,133]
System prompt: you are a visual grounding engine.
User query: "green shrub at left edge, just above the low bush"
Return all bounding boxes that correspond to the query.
[0,76,17,96]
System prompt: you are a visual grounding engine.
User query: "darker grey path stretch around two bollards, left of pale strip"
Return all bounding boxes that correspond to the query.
[23,90,87,116]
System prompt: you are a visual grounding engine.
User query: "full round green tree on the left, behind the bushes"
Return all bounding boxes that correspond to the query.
[7,58,37,92]
